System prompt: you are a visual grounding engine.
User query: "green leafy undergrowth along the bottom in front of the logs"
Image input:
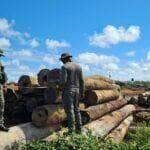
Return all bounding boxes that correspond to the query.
[18,124,150,150]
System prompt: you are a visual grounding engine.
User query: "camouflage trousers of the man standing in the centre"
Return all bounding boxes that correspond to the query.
[62,89,82,131]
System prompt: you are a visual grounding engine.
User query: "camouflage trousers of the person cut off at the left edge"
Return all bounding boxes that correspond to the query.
[0,84,4,125]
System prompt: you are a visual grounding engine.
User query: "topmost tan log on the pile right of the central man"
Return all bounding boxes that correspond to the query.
[84,78,115,90]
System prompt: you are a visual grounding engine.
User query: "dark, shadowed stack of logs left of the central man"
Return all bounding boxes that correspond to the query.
[4,69,61,125]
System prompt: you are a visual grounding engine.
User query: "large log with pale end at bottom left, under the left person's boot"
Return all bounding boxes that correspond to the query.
[0,123,60,150]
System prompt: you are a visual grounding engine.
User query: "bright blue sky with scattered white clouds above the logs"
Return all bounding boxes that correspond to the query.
[0,0,150,81]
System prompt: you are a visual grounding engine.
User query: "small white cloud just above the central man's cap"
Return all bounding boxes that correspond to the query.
[45,39,70,50]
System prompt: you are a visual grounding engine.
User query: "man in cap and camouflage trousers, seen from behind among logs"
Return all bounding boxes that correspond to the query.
[60,53,84,132]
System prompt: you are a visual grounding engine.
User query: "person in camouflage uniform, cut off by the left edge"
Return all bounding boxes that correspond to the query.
[0,49,8,131]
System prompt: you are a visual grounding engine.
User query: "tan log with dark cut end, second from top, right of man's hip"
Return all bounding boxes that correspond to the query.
[85,90,120,105]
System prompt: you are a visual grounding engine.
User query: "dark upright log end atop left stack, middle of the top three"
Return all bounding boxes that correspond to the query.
[37,69,50,86]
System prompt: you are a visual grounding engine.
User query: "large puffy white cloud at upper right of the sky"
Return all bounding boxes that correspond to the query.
[89,25,140,48]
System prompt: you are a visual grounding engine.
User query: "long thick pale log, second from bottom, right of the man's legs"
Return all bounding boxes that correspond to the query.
[83,105,135,137]
